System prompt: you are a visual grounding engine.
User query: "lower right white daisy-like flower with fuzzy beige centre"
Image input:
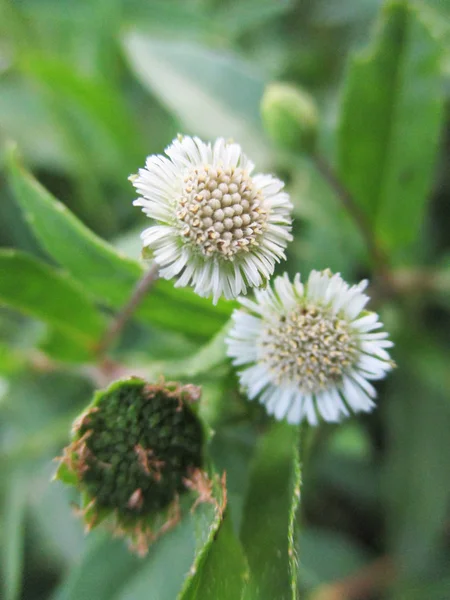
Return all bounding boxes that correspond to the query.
[227,270,393,425]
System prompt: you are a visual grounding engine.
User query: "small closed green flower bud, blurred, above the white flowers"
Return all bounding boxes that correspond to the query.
[261,83,319,152]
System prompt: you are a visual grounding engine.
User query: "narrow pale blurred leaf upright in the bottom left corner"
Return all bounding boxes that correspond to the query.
[2,471,26,600]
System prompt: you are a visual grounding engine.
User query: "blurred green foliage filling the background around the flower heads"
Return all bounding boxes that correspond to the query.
[0,0,450,600]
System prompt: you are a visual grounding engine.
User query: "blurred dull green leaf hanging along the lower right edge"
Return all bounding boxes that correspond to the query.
[384,327,450,579]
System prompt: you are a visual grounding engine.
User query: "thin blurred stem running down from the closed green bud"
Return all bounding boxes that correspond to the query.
[312,153,387,275]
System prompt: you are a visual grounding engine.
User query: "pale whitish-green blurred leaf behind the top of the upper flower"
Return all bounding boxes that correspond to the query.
[124,31,267,163]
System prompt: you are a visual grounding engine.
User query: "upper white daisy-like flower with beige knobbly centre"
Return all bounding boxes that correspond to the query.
[130,136,292,302]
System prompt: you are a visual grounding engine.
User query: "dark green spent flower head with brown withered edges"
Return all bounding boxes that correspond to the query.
[55,378,210,554]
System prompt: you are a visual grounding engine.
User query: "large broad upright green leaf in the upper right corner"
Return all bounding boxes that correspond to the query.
[338,0,443,257]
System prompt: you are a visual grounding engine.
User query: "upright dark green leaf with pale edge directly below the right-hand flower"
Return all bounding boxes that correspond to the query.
[241,423,300,600]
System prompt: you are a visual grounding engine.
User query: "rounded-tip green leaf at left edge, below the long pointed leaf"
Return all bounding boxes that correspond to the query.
[0,250,104,344]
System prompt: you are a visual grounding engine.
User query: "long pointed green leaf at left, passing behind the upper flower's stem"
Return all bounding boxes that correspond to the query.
[10,148,232,338]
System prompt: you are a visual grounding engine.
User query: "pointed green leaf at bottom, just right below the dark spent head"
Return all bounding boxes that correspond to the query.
[178,512,248,600]
